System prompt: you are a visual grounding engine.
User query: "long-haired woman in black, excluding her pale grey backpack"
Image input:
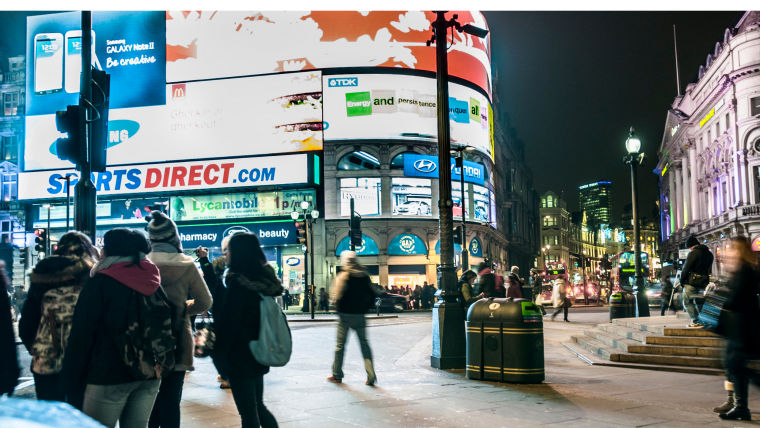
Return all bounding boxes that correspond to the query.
[215,232,282,428]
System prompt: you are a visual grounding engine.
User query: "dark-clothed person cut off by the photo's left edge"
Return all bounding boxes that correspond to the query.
[0,260,19,395]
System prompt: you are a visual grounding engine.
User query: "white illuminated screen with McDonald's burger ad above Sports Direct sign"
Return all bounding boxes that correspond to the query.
[24,71,322,171]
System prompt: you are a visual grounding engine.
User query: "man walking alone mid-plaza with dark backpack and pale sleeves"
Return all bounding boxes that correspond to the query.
[327,251,377,386]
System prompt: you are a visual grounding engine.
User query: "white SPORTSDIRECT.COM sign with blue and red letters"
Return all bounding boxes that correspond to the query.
[18,154,309,200]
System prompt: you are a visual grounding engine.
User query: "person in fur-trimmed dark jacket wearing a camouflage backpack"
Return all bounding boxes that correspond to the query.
[18,232,98,409]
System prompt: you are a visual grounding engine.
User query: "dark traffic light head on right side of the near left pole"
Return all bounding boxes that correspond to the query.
[90,69,110,172]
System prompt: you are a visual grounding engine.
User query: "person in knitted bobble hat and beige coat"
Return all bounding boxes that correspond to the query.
[147,211,213,428]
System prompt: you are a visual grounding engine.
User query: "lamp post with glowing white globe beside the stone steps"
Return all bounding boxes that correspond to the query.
[623,127,649,317]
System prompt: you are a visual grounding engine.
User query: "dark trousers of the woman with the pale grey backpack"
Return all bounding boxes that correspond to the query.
[230,375,277,428]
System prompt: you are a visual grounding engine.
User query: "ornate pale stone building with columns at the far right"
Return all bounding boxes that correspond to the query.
[654,11,760,275]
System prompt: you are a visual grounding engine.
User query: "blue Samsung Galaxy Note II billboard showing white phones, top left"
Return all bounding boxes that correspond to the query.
[26,11,166,115]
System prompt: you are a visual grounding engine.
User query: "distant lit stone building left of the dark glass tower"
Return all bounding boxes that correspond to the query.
[536,191,571,270]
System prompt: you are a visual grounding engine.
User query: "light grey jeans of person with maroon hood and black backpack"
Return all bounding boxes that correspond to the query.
[84,379,161,428]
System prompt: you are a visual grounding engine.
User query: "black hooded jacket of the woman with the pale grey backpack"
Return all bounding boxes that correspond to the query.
[214,264,283,378]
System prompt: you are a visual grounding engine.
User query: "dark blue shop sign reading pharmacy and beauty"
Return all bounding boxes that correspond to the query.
[177,221,296,248]
